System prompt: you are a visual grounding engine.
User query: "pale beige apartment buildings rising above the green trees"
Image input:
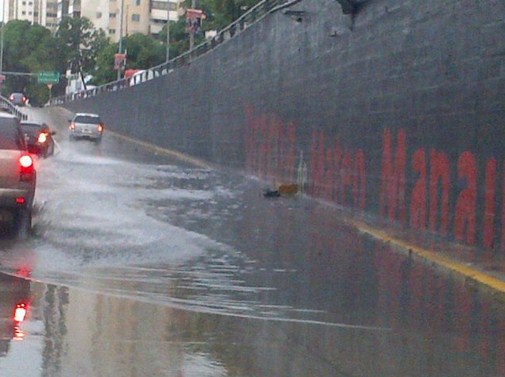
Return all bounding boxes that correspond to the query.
[4,0,182,42]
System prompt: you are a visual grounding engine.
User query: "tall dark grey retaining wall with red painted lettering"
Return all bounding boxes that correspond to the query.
[64,0,505,253]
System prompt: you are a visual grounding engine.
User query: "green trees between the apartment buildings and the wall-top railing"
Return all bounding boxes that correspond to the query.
[2,0,260,92]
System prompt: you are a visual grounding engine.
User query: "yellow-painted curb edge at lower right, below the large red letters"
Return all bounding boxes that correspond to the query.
[351,221,505,293]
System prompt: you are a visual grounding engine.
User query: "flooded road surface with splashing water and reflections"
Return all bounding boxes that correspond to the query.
[0,109,505,377]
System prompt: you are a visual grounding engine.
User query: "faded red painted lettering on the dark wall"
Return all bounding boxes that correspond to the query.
[244,108,505,249]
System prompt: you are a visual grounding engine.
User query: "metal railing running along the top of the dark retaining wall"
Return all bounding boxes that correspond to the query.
[49,0,301,105]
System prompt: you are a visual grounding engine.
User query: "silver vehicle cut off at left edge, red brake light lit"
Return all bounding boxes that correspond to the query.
[0,112,37,236]
